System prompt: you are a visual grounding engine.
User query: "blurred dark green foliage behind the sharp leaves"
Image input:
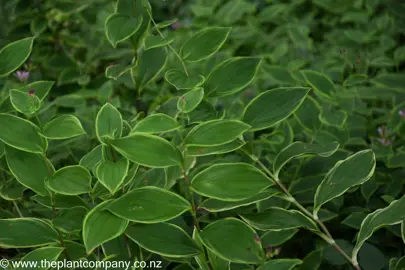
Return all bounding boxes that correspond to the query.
[0,0,405,270]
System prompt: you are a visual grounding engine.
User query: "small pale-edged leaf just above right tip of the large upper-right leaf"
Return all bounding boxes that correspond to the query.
[301,70,336,98]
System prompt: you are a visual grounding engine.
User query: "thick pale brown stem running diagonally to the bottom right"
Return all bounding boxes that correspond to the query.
[242,150,361,270]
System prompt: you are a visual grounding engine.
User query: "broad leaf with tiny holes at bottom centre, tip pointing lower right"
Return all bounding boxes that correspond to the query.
[200,218,263,264]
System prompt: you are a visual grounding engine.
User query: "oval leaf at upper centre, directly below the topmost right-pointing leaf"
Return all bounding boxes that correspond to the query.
[204,57,262,97]
